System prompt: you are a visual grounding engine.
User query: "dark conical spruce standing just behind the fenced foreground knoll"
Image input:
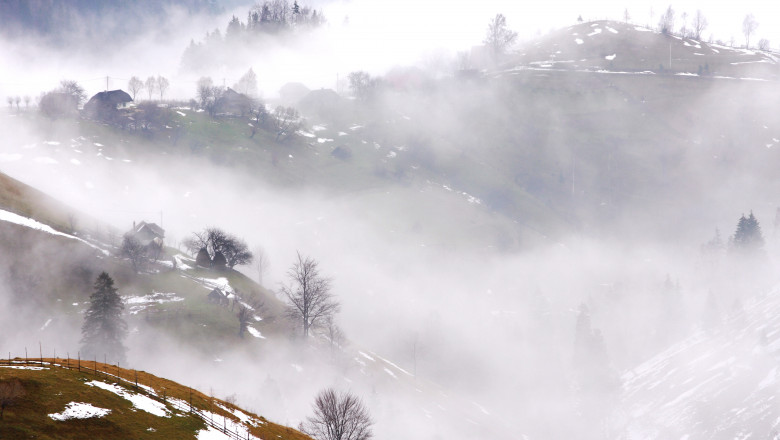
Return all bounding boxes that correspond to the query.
[81,272,127,363]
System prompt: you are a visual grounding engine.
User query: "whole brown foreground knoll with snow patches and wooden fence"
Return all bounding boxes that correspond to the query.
[0,358,309,440]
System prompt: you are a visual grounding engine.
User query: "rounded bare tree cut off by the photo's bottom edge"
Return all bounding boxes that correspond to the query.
[301,388,374,440]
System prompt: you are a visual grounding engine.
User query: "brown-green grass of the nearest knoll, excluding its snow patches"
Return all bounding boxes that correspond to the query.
[0,359,309,440]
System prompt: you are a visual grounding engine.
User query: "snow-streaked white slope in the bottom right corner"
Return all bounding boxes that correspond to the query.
[620,286,780,439]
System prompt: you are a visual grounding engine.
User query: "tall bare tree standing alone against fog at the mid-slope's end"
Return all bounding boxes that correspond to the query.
[282,252,340,337]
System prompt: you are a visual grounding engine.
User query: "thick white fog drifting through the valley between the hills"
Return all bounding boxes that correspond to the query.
[0,2,780,439]
